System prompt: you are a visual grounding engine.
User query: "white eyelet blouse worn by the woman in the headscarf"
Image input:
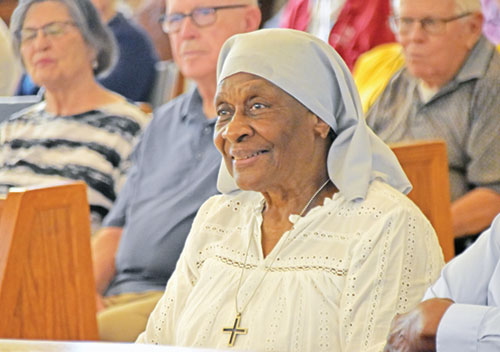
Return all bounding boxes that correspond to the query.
[138,181,443,352]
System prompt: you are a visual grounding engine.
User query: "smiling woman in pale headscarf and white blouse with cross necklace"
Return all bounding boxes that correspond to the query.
[138,29,442,352]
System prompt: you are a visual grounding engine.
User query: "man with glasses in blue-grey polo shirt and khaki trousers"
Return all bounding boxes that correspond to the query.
[93,0,261,341]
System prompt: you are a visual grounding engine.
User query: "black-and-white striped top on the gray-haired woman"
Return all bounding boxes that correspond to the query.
[0,101,149,230]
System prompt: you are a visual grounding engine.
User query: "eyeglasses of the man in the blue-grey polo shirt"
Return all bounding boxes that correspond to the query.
[160,4,248,33]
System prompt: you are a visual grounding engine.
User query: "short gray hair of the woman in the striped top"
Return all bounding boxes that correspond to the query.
[10,0,117,75]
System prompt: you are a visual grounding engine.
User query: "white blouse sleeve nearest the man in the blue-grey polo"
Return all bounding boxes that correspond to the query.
[136,197,217,345]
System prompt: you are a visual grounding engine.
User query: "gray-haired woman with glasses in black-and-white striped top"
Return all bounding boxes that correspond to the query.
[0,0,147,229]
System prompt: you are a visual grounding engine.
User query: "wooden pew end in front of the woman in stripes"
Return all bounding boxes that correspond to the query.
[0,182,98,340]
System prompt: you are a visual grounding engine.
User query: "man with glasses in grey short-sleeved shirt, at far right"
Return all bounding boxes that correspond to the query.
[367,0,500,253]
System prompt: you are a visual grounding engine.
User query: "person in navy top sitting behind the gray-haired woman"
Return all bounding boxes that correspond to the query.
[17,0,158,102]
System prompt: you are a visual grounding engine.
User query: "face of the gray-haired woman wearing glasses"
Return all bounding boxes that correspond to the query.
[21,1,95,89]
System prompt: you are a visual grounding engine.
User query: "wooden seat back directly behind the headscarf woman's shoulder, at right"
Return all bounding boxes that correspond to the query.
[391,140,455,261]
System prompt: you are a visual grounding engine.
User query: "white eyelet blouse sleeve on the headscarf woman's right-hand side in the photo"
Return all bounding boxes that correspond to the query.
[339,206,443,352]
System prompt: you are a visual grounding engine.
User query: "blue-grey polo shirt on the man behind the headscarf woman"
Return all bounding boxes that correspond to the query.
[104,89,221,295]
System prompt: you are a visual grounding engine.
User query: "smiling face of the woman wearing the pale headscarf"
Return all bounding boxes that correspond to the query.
[214,73,329,192]
